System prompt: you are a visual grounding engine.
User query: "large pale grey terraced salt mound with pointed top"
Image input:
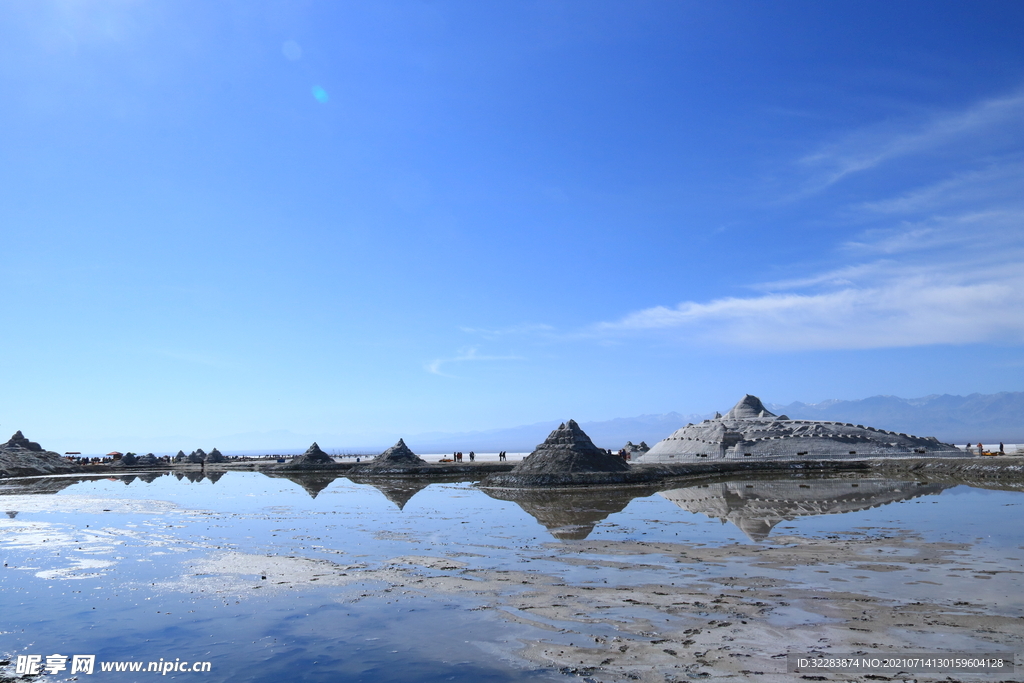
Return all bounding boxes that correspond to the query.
[634,394,964,464]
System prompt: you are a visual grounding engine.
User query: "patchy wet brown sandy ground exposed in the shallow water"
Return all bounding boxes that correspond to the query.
[153,532,1024,683]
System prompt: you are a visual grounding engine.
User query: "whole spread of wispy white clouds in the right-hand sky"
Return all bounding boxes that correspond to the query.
[589,87,1024,350]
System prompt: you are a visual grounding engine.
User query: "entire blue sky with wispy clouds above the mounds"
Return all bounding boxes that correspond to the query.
[0,0,1024,451]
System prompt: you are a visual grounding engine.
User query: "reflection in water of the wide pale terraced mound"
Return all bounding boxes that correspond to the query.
[660,479,949,541]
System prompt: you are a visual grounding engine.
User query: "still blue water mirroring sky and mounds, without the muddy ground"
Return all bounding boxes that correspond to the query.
[0,472,1024,683]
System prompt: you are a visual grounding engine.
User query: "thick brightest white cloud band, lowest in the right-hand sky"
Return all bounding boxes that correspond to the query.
[594,269,1024,350]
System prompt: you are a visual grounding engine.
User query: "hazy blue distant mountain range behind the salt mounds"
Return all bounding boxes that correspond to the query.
[406,391,1024,453]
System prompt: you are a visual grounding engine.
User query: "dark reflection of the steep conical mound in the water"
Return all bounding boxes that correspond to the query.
[483,486,653,541]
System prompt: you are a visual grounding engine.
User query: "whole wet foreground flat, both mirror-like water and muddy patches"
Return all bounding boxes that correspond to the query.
[0,472,1024,681]
